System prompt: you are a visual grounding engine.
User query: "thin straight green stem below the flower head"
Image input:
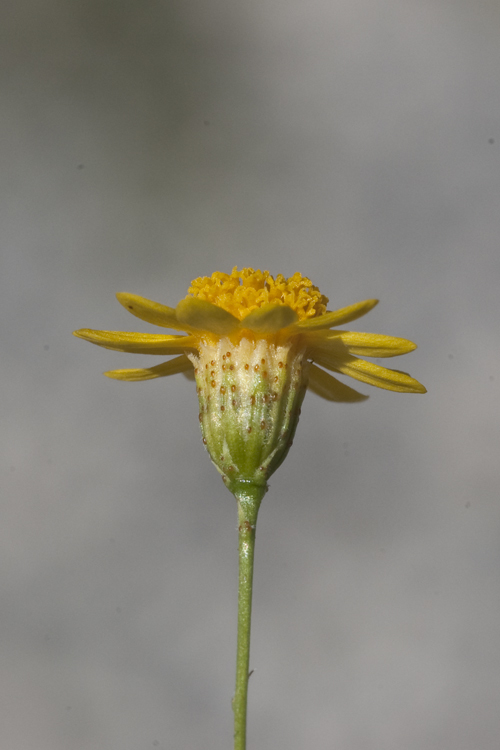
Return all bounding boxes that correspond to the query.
[233,482,267,750]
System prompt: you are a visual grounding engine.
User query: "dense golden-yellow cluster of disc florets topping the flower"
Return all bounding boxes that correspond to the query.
[188,267,328,320]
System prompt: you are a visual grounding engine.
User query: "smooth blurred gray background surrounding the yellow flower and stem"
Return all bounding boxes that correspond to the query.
[0,0,500,750]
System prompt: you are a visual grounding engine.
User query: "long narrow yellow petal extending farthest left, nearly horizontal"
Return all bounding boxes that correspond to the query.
[73,328,196,354]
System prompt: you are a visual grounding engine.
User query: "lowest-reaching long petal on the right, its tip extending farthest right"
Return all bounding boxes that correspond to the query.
[314,350,427,393]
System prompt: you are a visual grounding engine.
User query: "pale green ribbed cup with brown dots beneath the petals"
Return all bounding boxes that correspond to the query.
[190,338,309,493]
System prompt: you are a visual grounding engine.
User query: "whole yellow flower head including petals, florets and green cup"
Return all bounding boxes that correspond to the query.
[75,268,426,492]
